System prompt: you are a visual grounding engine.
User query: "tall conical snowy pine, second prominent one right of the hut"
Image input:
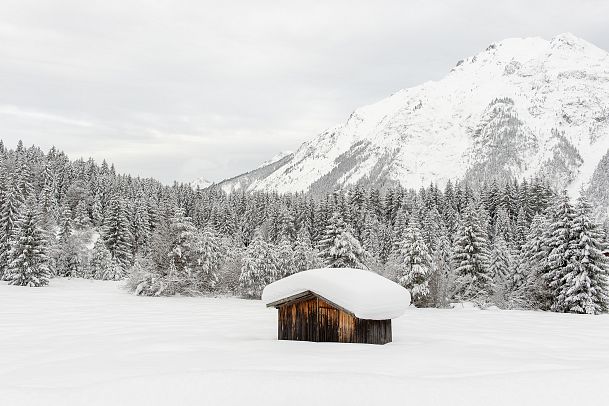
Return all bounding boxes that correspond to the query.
[453,205,492,300]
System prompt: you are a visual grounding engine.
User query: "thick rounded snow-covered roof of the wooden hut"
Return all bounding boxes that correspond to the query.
[262,268,410,320]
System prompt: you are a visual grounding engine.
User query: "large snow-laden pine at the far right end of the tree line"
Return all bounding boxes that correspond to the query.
[558,196,609,314]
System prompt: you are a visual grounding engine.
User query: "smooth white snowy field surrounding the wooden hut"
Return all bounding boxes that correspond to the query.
[0,279,609,406]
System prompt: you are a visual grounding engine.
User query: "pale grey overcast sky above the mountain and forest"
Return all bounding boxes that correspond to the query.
[0,0,609,182]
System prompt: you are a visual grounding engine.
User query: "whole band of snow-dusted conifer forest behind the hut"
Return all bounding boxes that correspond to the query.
[0,141,609,313]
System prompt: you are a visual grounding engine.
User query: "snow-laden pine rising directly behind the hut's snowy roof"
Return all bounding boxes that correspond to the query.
[319,212,367,269]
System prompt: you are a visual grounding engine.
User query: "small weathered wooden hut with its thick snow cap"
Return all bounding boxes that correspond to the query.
[262,268,410,344]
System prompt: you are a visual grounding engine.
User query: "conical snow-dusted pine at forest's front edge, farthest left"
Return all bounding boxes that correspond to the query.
[5,200,51,286]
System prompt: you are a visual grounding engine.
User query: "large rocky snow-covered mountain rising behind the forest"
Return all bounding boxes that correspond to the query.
[219,33,609,192]
